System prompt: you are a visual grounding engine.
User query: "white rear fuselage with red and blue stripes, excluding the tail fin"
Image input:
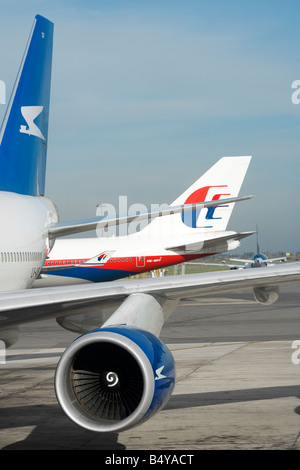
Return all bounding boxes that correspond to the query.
[33,231,239,287]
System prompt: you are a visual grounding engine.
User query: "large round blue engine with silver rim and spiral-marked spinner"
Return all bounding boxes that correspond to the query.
[55,326,175,432]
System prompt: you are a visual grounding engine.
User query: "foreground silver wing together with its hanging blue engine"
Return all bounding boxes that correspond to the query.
[0,263,300,432]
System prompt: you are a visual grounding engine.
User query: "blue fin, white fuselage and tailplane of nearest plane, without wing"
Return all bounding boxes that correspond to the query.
[0,15,236,291]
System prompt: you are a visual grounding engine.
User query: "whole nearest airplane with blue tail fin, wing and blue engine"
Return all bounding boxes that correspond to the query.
[0,15,300,433]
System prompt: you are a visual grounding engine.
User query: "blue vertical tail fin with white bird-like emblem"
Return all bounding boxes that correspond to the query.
[0,15,53,196]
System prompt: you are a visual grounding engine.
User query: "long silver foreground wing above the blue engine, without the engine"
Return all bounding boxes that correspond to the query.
[0,262,300,330]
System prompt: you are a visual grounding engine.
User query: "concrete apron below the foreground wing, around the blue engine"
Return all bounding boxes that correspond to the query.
[0,285,300,452]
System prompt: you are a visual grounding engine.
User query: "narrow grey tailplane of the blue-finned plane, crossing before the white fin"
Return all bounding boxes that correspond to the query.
[48,196,253,238]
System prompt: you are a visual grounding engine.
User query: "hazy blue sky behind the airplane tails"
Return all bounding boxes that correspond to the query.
[0,0,300,252]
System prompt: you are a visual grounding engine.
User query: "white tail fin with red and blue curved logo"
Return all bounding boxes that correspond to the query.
[140,156,251,237]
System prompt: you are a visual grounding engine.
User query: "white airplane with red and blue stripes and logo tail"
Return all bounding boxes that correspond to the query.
[33,157,254,287]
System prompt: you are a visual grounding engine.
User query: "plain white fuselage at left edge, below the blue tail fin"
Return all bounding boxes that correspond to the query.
[0,191,58,291]
